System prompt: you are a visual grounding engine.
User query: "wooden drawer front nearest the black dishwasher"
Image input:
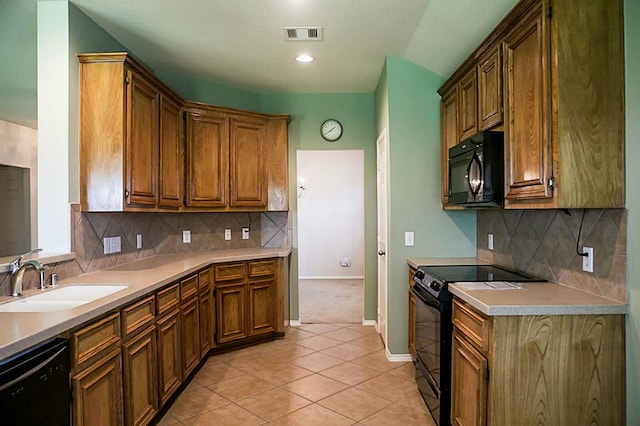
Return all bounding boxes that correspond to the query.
[71,313,120,368]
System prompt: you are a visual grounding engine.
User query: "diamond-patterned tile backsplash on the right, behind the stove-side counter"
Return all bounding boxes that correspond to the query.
[477,209,627,302]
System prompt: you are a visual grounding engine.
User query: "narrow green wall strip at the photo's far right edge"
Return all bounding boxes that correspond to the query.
[624,0,640,426]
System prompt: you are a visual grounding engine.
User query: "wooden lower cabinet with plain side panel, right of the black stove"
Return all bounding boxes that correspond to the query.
[451,299,625,426]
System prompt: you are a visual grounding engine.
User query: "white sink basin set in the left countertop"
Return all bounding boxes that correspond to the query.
[0,284,129,312]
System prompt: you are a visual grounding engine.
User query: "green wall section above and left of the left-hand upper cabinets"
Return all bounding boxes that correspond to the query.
[69,3,127,203]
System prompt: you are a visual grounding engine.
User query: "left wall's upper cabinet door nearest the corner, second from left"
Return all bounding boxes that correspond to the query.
[160,96,184,207]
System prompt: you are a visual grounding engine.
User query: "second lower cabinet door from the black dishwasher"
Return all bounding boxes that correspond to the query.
[122,326,158,425]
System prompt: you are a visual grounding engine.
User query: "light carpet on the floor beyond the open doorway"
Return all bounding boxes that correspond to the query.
[298,279,364,324]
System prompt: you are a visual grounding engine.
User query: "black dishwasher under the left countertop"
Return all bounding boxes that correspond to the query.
[0,338,71,426]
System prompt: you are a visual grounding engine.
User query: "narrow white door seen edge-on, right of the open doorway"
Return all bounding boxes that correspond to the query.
[376,129,389,346]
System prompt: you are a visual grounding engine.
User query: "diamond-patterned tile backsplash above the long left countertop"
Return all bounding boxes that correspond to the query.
[0,204,290,295]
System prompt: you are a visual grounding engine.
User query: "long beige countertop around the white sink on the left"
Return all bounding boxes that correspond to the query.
[0,248,291,360]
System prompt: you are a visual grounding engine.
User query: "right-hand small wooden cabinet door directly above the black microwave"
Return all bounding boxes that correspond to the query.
[478,46,502,130]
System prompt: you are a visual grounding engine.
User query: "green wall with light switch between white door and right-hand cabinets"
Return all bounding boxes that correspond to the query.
[376,57,476,354]
